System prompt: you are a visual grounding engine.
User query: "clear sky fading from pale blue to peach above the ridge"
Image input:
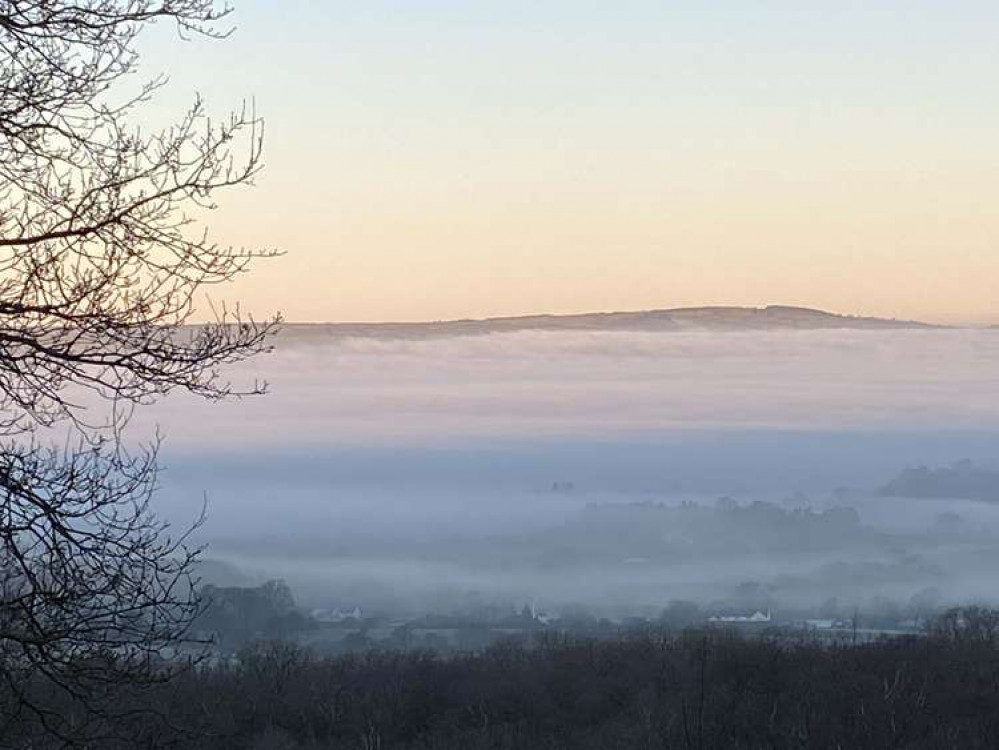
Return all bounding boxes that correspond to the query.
[135,0,999,323]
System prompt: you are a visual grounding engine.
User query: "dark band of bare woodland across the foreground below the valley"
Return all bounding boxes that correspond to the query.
[2,622,999,750]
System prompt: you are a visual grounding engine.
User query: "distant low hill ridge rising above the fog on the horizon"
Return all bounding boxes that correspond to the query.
[281,305,946,340]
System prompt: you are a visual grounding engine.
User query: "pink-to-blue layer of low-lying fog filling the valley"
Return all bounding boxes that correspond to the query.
[132,327,999,612]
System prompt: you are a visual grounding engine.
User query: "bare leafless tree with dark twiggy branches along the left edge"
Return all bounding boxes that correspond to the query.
[0,0,278,747]
